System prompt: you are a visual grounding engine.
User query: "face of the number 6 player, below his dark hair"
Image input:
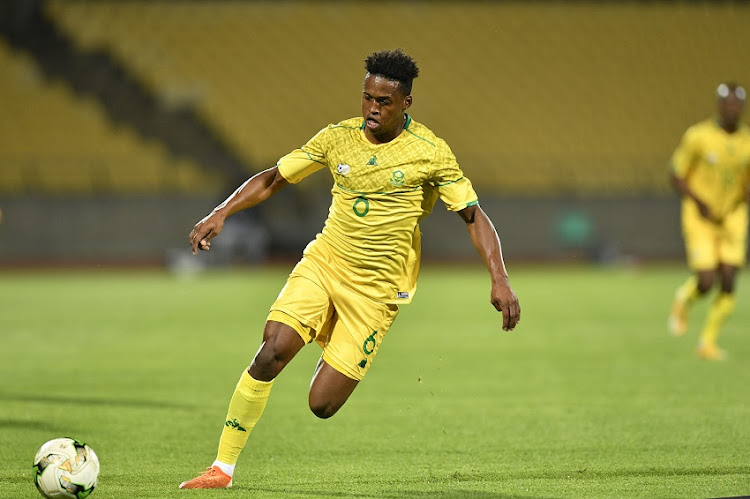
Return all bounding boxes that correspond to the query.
[362,73,411,143]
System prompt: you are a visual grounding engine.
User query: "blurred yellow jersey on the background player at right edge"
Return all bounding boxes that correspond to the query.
[672,119,750,218]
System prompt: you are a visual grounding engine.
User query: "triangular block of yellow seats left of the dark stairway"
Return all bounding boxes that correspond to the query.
[0,41,220,194]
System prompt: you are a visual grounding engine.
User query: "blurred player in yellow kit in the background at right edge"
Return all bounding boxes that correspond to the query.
[669,83,750,360]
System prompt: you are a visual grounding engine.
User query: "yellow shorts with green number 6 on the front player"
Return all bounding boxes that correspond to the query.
[267,257,398,381]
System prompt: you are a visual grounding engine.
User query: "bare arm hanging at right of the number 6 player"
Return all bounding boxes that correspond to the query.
[458,204,521,331]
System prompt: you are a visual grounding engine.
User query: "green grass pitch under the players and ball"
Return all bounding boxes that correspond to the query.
[0,266,750,499]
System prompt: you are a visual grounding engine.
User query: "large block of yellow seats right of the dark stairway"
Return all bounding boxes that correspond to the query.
[47,0,750,195]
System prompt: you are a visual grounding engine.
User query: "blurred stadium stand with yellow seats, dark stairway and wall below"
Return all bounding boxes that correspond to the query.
[0,0,750,266]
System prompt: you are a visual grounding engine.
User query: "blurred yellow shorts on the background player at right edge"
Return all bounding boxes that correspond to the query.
[682,204,748,271]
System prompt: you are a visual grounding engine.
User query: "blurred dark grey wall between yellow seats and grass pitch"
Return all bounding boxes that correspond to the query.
[0,195,682,267]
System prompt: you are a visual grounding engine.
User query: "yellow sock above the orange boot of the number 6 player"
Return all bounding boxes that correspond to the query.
[216,371,273,464]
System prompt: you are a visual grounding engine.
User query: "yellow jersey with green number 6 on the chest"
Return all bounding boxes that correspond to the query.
[277,115,477,304]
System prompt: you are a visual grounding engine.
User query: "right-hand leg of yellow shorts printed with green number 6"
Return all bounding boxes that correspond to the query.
[323,285,398,380]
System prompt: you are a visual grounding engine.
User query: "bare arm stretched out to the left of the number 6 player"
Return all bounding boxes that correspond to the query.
[190,166,289,254]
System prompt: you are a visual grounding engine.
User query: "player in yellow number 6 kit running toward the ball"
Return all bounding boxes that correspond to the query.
[180,49,520,489]
